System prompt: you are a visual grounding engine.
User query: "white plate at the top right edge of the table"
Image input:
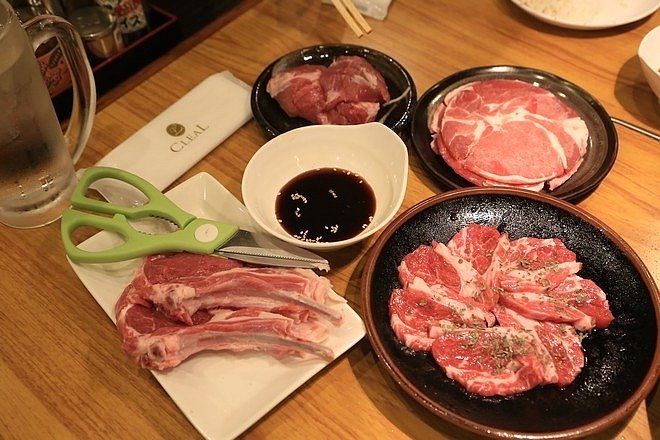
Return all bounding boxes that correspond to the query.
[511,0,660,30]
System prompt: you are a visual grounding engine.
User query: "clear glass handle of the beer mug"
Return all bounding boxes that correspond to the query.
[23,15,96,164]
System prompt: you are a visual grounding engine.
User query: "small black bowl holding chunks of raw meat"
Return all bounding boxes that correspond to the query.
[250,44,417,139]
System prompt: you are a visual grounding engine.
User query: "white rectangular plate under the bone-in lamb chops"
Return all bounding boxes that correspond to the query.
[70,173,365,440]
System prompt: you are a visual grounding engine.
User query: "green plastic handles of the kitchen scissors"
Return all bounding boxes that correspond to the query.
[61,167,238,263]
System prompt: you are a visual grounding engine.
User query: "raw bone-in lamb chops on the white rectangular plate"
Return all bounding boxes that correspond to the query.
[115,253,342,370]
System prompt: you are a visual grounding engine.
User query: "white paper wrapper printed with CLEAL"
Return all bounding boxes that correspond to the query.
[94,71,252,198]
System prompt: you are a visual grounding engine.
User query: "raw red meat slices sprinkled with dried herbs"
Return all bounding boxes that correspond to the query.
[389,224,614,396]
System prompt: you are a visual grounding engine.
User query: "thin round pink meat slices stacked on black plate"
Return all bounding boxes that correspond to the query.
[429,79,589,191]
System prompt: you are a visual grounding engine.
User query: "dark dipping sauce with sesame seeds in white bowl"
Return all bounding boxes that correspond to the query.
[275,168,376,243]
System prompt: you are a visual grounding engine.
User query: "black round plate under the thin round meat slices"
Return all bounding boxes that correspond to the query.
[410,66,619,202]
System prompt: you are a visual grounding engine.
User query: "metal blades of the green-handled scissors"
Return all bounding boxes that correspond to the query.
[214,230,330,272]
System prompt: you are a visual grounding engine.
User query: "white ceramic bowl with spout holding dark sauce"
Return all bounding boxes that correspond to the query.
[242,122,408,251]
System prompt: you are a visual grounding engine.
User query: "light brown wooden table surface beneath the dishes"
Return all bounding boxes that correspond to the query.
[0,0,660,440]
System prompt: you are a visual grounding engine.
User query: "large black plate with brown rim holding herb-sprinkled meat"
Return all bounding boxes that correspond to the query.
[361,188,660,440]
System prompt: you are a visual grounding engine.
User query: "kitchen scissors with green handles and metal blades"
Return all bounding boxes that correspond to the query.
[61,167,329,270]
